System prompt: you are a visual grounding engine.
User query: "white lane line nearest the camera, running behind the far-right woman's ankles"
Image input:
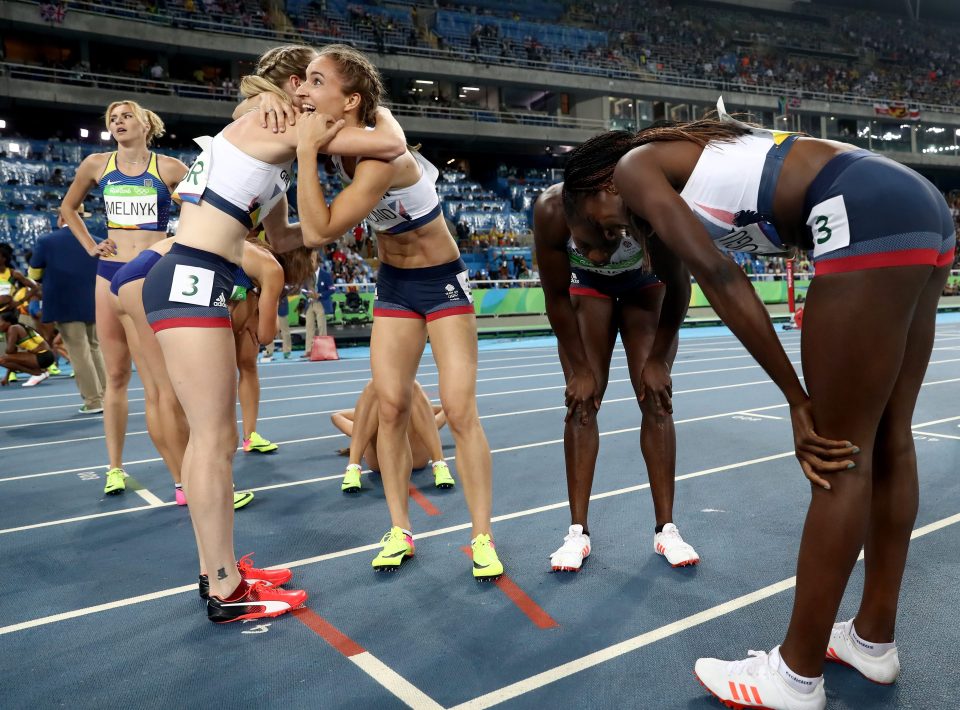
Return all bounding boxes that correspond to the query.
[452,514,960,710]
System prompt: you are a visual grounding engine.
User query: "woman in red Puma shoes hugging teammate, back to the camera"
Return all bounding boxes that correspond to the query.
[143,47,402,623]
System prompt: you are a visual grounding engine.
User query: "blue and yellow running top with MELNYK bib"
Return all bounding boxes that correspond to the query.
[100,152,170,232]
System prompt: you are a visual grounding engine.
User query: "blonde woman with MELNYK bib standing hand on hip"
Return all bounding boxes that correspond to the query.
[60,101,187,494]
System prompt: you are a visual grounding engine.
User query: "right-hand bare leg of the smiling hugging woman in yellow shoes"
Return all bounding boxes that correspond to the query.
[427,314,493,537]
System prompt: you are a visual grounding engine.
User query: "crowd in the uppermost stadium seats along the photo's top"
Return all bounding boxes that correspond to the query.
[13,0,960,104]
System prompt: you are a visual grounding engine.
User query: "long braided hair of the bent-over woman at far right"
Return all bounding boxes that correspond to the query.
[563,118,749,216]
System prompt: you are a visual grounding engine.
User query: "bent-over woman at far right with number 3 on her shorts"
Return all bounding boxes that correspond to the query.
[564,103,956,708]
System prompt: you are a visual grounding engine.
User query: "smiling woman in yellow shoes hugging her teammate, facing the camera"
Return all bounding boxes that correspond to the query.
[297,45,503,579]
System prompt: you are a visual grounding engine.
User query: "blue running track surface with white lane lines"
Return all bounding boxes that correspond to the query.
[0,316,960,708]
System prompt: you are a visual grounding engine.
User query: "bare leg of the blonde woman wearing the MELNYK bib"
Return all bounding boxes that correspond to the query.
[96,276,130,468]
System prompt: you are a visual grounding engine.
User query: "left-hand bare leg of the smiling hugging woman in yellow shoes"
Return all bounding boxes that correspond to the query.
[370,317,426,530]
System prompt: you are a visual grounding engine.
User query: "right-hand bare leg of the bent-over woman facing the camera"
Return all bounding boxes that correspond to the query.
[620,288,678,528]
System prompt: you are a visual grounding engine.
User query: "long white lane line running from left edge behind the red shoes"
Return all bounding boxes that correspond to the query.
[0,451,793,636]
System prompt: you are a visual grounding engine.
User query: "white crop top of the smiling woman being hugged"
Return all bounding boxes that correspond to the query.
[330,150,440,234]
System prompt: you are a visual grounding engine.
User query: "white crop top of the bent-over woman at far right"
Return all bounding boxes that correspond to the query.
[680,99,797,254]
